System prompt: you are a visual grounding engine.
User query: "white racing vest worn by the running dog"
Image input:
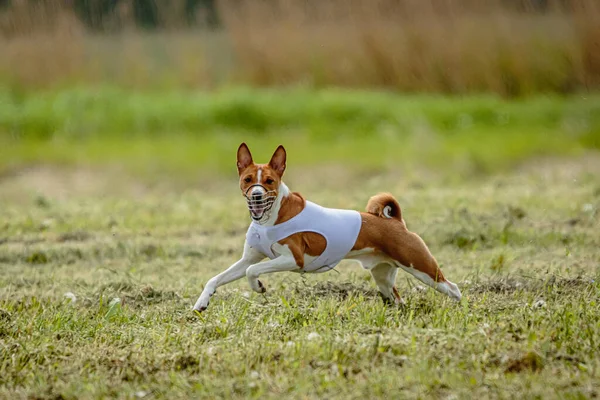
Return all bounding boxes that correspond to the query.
[246,201,362,272]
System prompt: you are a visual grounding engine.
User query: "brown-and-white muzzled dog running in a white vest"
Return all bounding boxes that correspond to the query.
[193,143,462,312]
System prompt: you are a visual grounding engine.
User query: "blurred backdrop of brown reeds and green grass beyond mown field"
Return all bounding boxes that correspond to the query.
[0,0,600,184]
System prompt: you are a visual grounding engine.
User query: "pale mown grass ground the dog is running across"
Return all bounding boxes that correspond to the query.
[0,152,600,399]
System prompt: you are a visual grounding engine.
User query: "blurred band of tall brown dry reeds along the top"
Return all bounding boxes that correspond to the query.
[0,0,600,95]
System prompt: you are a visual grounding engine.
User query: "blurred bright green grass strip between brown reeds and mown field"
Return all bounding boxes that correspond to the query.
[0,87,600,177]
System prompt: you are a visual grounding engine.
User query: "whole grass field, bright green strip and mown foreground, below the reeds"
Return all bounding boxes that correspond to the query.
[0,90,600,399]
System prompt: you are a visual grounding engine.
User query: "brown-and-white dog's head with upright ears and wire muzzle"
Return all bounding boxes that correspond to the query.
[237,143,286,222]
